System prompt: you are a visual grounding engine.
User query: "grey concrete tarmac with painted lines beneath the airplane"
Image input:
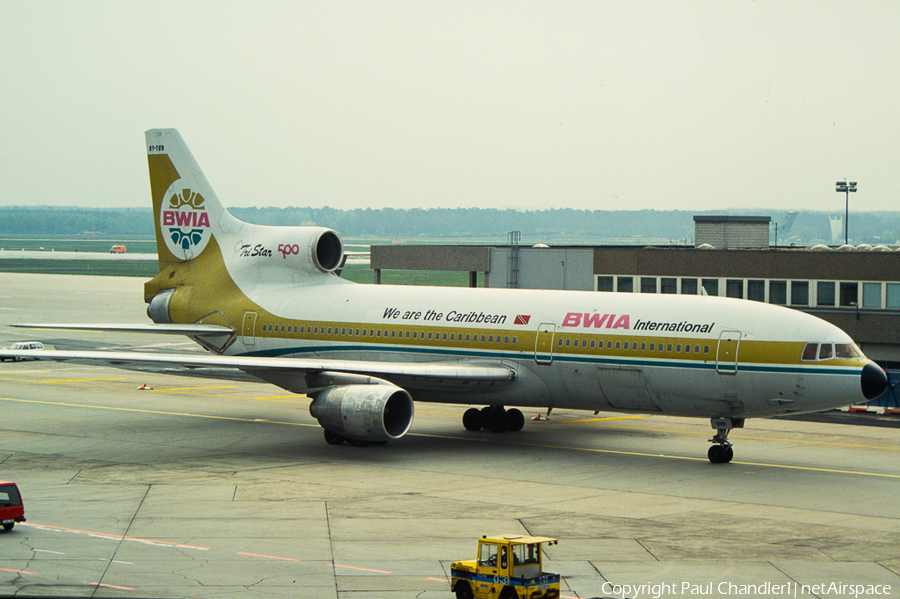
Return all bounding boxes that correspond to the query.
[0,273,900,599]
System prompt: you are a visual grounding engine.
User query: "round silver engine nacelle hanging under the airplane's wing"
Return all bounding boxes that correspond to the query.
[309,385,413,442]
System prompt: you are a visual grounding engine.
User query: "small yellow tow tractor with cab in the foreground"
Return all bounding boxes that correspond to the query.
[450,535,559,599]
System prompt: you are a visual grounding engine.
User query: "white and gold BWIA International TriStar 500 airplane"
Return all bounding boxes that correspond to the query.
[0,129,888,463]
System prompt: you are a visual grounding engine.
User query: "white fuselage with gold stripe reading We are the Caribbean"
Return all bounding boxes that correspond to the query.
[221,276,865,418]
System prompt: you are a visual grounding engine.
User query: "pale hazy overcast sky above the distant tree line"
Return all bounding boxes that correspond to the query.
[0,0,900,212]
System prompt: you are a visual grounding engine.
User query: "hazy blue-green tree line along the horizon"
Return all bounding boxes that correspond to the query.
[0,206,900,245]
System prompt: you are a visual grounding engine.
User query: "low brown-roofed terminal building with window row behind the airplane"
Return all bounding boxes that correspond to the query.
[371,216,900,404]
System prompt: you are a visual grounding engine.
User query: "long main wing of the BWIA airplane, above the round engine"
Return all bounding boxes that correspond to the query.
[0,350,516,393]
